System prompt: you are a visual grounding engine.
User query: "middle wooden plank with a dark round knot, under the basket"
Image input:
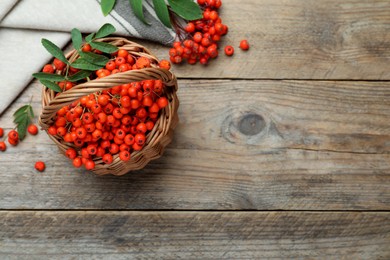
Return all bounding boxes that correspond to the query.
[0,80,390,210]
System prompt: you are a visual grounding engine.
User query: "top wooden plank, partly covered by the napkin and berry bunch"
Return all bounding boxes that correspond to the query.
[141,0,390,80]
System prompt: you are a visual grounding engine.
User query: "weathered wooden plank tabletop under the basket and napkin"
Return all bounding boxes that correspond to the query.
[0,0,390,259]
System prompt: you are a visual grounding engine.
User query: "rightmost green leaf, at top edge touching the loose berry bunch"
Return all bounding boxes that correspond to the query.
[168,0,203,21]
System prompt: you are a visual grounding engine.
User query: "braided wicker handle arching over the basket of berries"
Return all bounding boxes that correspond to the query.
[39,68,177,130]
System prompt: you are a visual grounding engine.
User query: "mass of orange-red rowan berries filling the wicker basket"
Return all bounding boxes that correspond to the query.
[48,49,170,170]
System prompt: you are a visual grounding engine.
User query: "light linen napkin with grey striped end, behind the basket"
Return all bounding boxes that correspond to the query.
[0,0,176,115]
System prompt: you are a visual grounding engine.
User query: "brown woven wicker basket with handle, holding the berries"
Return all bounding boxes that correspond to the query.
[39,37,179,175]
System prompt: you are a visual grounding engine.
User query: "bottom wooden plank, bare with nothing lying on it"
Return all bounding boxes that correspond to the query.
[0,211,390,259]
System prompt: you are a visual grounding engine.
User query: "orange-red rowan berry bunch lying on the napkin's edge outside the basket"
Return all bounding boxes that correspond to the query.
[169,0,228,65]
